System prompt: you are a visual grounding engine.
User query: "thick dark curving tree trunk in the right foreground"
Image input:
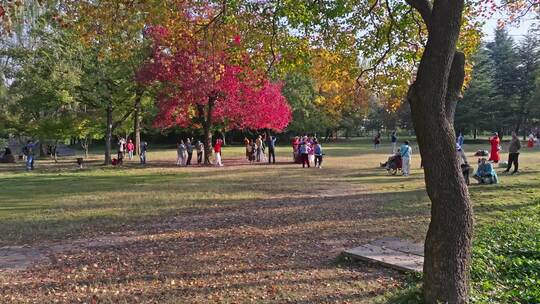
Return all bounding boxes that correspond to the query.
[408,0,473,304]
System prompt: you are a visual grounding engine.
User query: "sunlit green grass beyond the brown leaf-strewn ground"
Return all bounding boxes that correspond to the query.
[0,140,540,243]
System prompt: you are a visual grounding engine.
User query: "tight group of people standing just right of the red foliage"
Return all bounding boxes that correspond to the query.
[292,135,324,168]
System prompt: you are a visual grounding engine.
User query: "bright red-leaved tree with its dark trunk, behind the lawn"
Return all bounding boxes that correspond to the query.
[138,26,291,164]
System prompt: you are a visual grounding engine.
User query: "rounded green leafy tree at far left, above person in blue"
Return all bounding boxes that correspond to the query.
[7,29,80,152]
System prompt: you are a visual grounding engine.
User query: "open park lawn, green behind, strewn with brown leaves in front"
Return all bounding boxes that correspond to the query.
[0,140,540,303]
